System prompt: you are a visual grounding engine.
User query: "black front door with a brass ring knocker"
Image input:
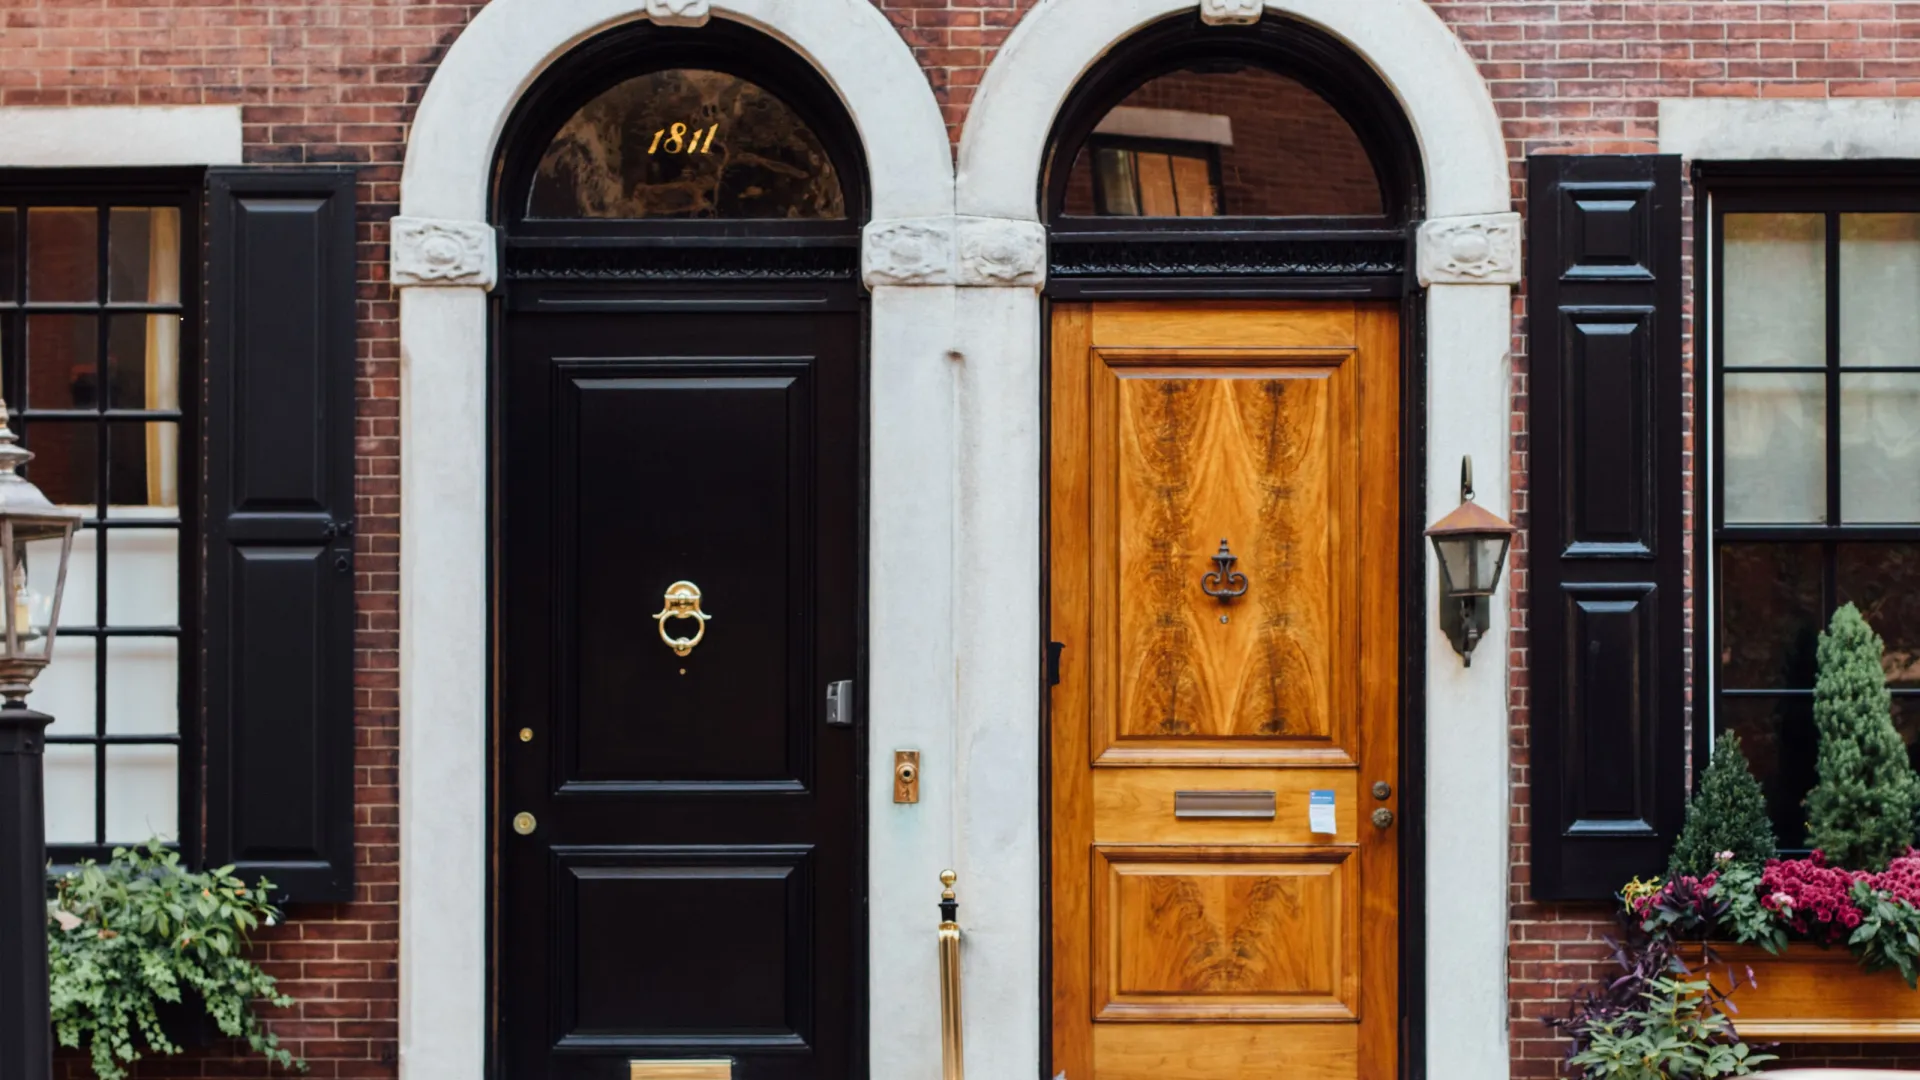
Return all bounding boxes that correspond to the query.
[493,305,866,1080]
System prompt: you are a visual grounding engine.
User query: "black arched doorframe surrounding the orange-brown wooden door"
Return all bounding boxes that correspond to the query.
[1035,12,1428,1080]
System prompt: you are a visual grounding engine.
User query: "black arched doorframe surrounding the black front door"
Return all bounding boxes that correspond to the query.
[486,19,872,1080]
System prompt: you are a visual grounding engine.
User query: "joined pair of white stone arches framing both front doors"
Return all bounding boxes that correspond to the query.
[392,0,1517,1080]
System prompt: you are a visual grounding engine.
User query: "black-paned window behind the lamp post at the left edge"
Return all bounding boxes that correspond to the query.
[0,173,200,859]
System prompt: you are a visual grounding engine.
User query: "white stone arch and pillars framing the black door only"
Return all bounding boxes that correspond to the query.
[392,0,954,1080]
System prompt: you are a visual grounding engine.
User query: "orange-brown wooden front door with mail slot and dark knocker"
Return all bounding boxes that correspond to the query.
[1050,304,1400,1080]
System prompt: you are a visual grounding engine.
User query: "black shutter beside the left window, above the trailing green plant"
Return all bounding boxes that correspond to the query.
[202,169,355,901]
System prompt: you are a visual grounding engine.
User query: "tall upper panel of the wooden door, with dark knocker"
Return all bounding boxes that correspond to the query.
[1092,348,1359,763]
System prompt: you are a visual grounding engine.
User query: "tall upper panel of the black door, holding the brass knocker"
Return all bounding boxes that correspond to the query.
[551,359,812,792]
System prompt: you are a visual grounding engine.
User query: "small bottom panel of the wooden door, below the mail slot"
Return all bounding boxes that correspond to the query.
[1092,846,1359,1020]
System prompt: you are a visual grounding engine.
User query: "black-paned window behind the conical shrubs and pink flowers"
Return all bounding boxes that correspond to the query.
[1703,177,1920,847]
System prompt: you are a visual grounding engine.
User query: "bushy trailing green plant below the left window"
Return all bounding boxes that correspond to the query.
[46,842,305,1080]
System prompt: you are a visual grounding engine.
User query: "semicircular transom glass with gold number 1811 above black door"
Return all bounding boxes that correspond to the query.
[526,69,847,221]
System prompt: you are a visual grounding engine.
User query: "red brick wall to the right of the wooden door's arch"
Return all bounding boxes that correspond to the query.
[1432,0,1920,1078]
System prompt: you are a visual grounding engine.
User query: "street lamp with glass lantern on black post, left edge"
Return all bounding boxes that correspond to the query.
[0,402,81,1080]
